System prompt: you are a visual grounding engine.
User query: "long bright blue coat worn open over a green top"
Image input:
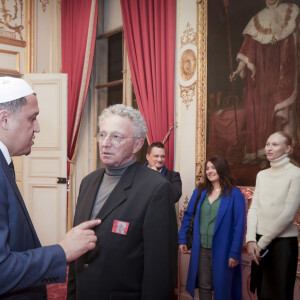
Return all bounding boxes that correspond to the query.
[178,188,246,300]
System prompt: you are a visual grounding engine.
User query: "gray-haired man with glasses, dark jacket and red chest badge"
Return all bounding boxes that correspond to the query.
[67,104,177,300]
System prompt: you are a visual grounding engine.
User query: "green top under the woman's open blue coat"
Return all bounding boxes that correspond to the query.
[200,193,222,249]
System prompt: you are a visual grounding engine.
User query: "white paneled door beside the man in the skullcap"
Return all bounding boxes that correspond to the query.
[23,74,67,246]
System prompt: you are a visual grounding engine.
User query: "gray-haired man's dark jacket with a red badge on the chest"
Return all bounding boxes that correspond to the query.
[67,163,178,300]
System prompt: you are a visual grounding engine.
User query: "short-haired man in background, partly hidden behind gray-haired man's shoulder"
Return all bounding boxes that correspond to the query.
[146,142,182,202]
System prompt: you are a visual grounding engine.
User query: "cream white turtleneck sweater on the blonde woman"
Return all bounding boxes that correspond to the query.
[246,154,300,249]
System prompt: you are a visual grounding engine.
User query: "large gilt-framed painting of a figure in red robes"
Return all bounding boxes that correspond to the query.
[196,0,300,186]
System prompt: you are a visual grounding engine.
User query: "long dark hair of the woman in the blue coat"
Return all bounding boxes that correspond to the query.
[198,156,233,195]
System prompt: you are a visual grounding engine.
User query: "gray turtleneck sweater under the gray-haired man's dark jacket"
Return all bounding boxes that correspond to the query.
[90,158,136,219]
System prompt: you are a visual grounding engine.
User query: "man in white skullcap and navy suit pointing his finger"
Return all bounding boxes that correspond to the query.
[0,77,100,300]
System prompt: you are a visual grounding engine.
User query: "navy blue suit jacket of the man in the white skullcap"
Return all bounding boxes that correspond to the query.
[0,150,66,300]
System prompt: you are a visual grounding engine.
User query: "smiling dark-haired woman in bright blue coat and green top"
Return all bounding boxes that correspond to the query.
[178,157,245,300]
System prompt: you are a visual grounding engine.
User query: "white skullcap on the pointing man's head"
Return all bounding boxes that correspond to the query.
[0,76,34,103]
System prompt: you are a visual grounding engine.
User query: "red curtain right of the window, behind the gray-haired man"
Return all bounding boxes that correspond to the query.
[121,0,176,169]
